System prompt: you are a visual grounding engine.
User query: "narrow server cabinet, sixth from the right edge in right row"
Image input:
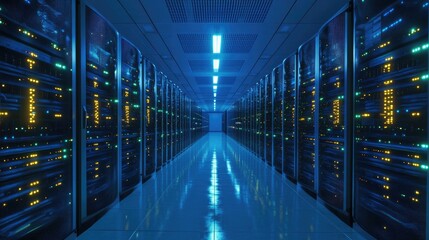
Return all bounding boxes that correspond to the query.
[265,74,273,165]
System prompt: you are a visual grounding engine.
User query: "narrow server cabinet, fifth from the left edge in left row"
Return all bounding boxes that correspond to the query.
[155,72,164,171]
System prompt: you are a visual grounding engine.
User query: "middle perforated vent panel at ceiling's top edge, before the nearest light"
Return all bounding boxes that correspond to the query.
[192,0,273,23]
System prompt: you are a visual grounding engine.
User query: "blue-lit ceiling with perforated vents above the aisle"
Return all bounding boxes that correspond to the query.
[87,0,349,111]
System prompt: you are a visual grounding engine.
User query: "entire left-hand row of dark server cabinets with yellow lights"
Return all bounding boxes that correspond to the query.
[0,0,207,239]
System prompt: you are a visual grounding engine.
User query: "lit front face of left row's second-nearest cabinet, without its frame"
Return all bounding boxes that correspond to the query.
[82,8,118,216]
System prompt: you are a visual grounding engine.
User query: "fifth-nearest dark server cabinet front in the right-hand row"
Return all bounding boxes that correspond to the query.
[273,67,284,172]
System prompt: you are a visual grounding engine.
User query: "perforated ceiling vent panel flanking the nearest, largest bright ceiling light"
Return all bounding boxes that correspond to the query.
[177,34,258,52]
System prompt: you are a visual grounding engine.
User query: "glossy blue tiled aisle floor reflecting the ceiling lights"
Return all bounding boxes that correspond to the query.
[78,133,362,240]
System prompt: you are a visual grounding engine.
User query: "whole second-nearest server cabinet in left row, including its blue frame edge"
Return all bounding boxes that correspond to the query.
[78,5,120,225]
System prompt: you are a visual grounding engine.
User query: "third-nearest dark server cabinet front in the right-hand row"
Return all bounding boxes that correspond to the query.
[298,38,316,191]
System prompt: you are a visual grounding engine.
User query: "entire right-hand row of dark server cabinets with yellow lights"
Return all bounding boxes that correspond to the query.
[226,0,429,239]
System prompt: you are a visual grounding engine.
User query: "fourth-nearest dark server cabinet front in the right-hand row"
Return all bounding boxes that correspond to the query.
[283,54,296,179]
